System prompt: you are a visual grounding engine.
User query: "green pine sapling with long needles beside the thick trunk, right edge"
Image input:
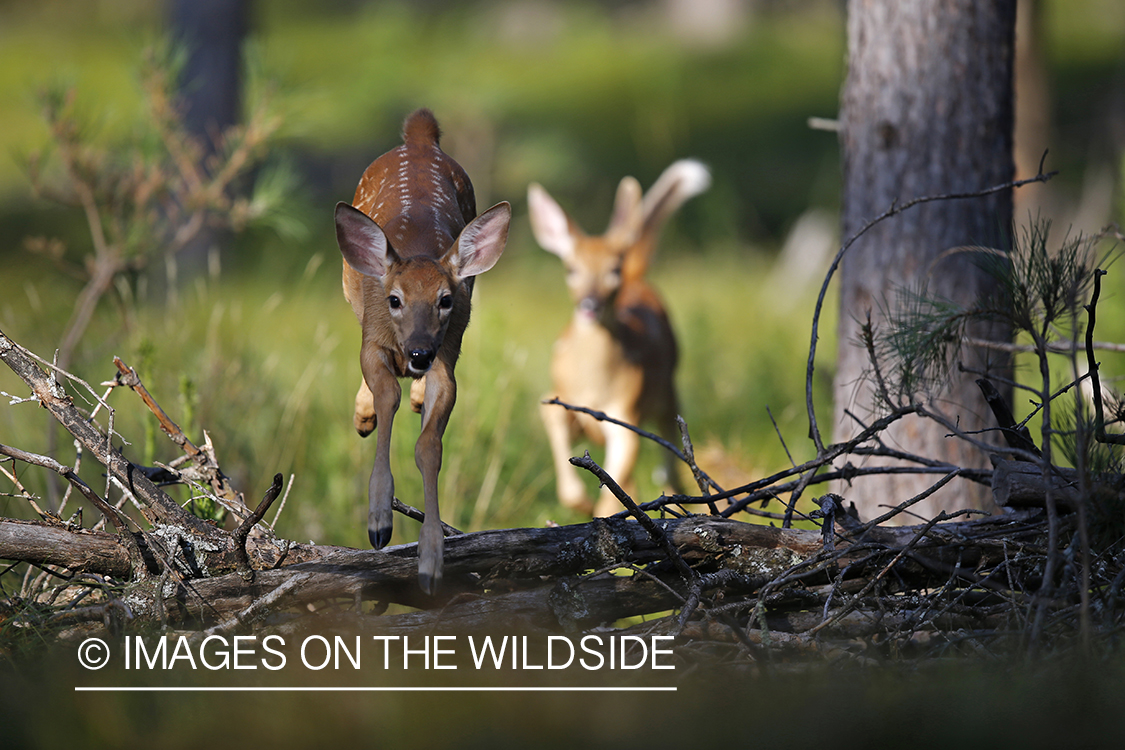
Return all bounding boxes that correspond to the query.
[866,220,1125,643]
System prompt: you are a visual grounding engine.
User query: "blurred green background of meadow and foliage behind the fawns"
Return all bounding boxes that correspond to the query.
[0,0,1125,545]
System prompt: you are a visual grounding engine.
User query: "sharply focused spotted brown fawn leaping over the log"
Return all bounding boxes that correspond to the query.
[335,109,512,594]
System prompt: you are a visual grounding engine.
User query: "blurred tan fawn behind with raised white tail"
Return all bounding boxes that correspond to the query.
[528,160,711,516]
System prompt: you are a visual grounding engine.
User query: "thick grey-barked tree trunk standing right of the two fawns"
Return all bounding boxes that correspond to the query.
[834,0,1016,517]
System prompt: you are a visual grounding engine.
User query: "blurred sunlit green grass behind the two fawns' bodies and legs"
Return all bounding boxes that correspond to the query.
[0,226,833,546]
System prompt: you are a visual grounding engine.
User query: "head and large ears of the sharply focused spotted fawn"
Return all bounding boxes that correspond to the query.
[336,202,511,378]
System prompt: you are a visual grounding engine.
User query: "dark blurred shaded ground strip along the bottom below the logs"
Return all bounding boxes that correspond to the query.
[0,647,1125,749]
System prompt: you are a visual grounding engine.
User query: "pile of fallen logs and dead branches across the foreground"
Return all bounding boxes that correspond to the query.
[0,323,1125,661]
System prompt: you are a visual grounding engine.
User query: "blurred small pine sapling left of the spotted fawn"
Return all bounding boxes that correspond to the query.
[27,41,295,368]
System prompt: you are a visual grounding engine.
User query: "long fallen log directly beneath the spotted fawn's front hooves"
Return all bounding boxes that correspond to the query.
[154,516,821,629]
